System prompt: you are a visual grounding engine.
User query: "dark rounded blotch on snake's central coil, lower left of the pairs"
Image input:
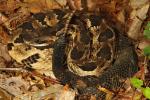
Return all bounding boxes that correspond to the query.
[71,47,84,60]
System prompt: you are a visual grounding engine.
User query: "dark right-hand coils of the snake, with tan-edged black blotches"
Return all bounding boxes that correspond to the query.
[52,10,138,100]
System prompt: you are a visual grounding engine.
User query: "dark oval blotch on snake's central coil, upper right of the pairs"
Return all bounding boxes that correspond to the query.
[98,28,114,42]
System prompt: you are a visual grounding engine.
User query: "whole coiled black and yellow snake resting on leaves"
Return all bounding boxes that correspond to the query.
[7,9,138,100]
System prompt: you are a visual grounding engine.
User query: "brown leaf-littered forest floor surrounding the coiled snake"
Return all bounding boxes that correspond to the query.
[0,0,150,100]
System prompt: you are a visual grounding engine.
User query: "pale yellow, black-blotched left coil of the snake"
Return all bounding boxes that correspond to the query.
[7,10,71,78]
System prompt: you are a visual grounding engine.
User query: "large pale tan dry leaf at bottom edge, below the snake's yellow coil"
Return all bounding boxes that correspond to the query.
[14,85,75,100]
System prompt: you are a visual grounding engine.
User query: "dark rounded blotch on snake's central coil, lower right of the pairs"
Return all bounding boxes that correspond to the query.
[97,45,111,60]
